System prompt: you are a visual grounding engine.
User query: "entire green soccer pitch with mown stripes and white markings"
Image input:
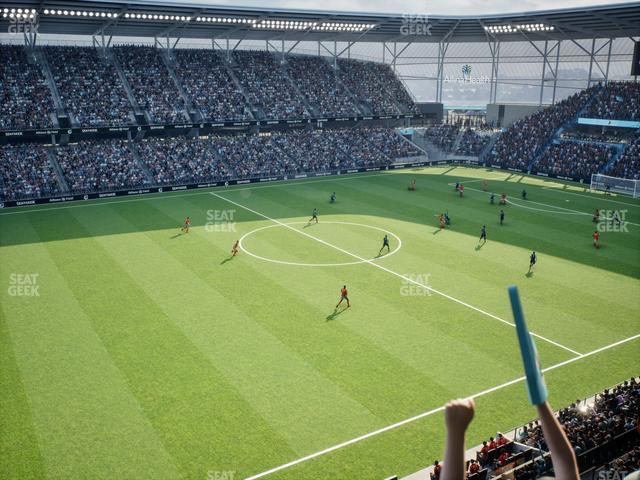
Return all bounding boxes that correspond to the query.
[0,166,640,480]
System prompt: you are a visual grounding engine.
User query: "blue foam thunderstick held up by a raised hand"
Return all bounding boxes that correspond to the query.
[509,285,549,405]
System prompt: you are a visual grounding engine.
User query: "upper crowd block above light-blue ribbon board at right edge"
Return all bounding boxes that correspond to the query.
[585,82,640,121]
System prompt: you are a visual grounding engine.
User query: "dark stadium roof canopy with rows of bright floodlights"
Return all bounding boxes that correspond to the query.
[0,0,640,42]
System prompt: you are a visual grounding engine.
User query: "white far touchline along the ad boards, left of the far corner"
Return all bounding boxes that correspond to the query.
[0,172,389,217]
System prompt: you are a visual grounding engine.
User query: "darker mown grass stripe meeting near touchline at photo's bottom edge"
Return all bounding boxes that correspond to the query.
[35,205,300,478]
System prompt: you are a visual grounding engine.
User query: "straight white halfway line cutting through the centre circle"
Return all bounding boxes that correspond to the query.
[209,192,582,356]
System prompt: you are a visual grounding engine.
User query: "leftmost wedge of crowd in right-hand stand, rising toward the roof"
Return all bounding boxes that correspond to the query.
[487,87,597,170]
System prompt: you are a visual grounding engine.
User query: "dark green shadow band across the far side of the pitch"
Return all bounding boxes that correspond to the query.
[0,169,640,278]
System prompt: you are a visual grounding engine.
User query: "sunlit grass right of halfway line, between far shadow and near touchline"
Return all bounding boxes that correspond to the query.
[284,174,640,351]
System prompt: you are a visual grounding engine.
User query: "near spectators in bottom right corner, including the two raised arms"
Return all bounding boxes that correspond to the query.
[430,377,640,480]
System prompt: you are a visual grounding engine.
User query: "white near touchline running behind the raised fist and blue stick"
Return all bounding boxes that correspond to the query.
[245,334,640,480]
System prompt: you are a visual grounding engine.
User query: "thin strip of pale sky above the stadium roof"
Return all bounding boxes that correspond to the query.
[149,0,633,15]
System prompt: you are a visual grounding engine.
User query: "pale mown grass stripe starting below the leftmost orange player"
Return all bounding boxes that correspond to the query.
[75,201,388,460]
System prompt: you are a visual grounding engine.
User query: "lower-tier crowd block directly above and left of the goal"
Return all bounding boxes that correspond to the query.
[531,142,615,180]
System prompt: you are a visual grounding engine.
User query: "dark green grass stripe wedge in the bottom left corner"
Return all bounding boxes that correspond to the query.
[0,308,46,479]
